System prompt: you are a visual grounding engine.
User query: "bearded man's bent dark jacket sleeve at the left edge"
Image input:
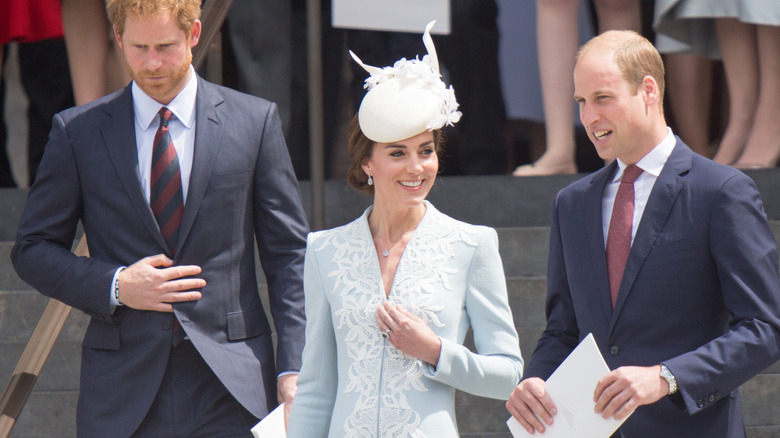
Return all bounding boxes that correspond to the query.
[11,114,119,321]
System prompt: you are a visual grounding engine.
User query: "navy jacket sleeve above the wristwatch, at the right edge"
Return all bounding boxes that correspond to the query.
[664,174,780,414]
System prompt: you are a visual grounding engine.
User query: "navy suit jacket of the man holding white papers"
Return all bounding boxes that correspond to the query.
[524,138,780,438]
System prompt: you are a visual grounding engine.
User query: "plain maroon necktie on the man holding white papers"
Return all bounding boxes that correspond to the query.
[607,164,642,308]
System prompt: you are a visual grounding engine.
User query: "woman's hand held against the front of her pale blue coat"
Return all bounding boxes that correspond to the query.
[376,301,441,368]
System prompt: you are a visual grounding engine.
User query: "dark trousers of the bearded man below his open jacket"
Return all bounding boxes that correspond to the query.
[133,340,259,438]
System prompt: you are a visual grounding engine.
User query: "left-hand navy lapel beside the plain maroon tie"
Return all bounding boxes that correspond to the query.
[582,162,617,318]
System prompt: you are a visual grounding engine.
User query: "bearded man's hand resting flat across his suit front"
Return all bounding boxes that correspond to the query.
[117,254,206,312]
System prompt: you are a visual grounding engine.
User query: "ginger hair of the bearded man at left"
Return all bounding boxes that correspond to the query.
[106,0,201,36]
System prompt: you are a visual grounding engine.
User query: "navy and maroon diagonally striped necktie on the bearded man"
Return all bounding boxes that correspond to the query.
[149,107,184,254]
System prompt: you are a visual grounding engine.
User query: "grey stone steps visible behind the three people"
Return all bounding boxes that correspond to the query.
[0,170,780,438]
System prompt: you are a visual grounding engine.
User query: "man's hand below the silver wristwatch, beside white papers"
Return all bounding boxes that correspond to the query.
[593,365,669,420]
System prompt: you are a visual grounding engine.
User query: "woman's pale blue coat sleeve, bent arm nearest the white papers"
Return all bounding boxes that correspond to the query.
[426,228,523,400]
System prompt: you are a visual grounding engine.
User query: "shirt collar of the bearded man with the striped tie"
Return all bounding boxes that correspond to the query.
[132,65,198,131]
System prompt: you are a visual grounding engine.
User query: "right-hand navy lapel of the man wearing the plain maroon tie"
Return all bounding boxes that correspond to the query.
[610,138,693,331]
